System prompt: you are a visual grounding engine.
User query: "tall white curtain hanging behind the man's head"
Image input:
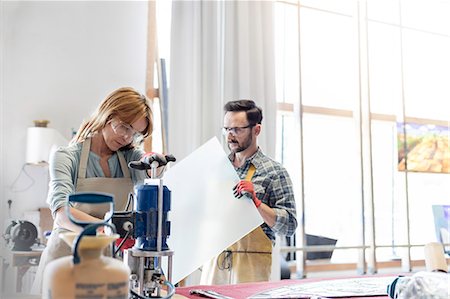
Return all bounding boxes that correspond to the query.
[168,1,276,159]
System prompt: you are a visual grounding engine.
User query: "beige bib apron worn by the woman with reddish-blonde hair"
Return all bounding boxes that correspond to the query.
[31,138,133,294]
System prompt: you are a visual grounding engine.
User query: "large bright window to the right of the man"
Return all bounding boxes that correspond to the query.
[275,0,450,276]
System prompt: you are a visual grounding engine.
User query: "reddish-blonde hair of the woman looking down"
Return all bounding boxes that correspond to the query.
[72,87,153,148]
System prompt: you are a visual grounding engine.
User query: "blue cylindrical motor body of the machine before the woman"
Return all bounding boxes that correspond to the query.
[134,184,171,251]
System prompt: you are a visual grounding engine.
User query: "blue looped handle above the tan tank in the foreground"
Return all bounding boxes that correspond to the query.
[66,192,114,235]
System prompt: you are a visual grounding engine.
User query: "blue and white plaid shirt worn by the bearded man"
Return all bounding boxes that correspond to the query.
[229,148,297,242]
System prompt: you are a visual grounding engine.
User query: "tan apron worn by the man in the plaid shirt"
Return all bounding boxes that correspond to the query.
[200,164,272,285]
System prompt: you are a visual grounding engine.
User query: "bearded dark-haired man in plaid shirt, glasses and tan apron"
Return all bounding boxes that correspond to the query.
[201,100,297,284]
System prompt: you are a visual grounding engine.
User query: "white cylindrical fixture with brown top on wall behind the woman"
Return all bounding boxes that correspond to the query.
[25,120,68,165]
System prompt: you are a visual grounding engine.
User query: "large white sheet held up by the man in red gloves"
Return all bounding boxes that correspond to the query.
[163,137,263,283]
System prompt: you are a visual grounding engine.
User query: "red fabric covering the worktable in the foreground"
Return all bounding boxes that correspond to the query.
[176,275,395,299]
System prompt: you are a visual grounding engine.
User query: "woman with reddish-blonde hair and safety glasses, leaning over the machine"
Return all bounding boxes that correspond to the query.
[32,87,158,294]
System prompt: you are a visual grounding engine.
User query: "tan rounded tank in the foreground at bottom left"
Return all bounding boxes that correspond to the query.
[42,232,130,299]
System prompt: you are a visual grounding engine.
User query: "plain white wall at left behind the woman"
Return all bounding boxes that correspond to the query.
[0,1,147,232]
